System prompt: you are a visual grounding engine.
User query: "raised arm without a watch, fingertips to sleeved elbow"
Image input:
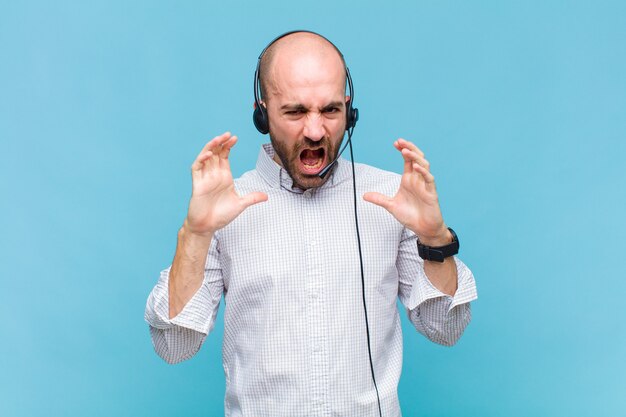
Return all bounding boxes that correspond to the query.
[145,132,267,363]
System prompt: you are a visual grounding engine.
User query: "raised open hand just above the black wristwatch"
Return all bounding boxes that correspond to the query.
[363,139,451,246]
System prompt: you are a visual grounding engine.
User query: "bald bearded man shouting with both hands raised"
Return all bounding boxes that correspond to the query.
[146,32,476,417]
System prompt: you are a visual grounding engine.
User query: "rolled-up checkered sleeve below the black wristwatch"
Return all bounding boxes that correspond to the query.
[396,231,478,346]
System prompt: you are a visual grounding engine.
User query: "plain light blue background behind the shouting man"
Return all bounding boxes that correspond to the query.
[0,1,626,417]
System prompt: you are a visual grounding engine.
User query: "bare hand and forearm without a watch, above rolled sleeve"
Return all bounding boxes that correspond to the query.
[168,132,267,319]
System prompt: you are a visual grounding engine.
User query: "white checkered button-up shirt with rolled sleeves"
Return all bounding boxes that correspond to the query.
[145,145,476,417]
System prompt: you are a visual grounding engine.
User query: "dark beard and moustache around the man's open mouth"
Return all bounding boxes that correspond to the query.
[269,131,341,190]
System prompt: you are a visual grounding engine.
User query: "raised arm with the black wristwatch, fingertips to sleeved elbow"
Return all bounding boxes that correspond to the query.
[363,139,476,345]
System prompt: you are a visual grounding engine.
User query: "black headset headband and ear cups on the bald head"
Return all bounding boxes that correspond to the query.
[252,30,359,135]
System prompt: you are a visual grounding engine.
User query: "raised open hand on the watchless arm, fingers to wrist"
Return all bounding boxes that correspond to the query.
[185,132,267,235]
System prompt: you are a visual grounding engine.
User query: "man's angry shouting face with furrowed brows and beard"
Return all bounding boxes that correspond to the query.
[266,48,346,190]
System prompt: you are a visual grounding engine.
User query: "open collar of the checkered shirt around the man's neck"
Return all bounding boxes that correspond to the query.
[256,143,351,190]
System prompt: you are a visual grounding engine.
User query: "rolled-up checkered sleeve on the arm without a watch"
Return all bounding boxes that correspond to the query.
[144,238,224,363]
